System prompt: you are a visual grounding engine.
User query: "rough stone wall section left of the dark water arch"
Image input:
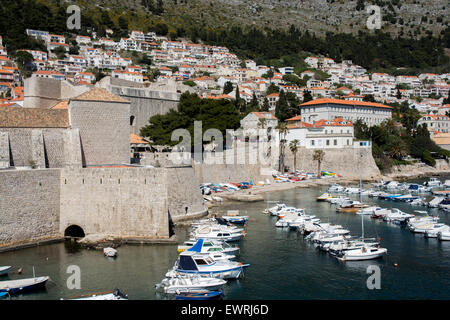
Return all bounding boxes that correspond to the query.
[0,169,61,250]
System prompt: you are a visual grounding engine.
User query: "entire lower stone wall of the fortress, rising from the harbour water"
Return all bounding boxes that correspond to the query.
[0,167,207,251]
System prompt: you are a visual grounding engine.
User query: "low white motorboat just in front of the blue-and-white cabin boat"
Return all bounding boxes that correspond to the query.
[155,275,227,294]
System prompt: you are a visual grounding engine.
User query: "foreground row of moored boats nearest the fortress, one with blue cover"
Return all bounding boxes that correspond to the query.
[155,211,249,300]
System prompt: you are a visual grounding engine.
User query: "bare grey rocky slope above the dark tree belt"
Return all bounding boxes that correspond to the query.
[62,0,449,37]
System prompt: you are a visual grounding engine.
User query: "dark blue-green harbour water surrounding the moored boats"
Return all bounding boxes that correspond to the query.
[0,180,450,300]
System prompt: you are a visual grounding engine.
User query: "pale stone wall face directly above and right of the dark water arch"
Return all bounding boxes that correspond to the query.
[60,168,169,239]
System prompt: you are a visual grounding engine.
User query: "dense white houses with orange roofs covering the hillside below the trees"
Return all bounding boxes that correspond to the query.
[0,29,450,132]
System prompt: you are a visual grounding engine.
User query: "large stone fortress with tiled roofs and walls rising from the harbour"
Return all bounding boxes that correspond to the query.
[0,78,206,250]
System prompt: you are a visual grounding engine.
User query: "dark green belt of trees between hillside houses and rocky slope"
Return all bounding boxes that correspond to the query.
[0,0,450,73]
